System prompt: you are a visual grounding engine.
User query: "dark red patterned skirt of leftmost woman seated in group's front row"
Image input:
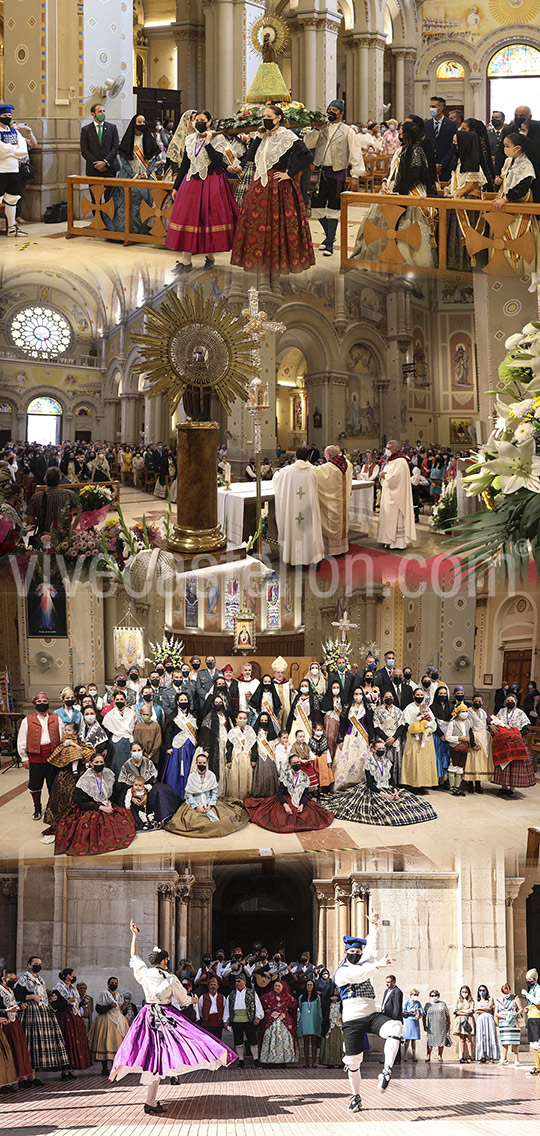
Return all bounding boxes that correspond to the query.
[55,804,136,855]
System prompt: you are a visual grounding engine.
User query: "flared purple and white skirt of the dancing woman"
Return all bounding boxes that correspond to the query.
[109,1004,236,1084]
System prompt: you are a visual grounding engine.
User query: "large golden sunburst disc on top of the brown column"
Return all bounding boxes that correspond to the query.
[133,287,257,412]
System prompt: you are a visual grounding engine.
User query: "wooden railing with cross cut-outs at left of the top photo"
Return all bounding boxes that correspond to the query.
[66,174,173,245]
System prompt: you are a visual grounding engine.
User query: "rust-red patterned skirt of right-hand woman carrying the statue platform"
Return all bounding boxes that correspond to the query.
[231,174,315,273]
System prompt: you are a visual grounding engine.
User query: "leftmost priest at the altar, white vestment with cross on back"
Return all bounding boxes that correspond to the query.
[273,445,324,566]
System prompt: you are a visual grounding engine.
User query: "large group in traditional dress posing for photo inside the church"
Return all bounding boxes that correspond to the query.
[17,651,540,855]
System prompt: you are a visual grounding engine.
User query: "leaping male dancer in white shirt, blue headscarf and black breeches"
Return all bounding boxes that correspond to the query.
[334,914,404,1112]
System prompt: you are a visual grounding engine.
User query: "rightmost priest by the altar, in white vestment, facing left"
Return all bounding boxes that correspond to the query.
[377,441,416,549]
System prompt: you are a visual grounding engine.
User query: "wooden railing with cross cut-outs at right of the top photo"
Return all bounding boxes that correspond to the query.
[341,192,540,276]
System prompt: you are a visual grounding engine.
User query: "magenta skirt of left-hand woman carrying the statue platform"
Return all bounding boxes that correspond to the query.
[165,174,238,253]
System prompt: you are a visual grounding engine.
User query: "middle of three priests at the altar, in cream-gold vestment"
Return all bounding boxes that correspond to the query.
[315,445,352,557]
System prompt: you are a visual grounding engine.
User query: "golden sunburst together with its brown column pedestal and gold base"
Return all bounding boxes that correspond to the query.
[133,287,257,556]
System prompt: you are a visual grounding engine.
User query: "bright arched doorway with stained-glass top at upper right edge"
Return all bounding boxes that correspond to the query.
[488,43,540,123]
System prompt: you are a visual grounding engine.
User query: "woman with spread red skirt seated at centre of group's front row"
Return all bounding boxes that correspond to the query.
[243,753,334,833]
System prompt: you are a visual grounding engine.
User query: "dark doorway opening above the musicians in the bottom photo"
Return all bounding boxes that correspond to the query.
[213,859,313,959]
